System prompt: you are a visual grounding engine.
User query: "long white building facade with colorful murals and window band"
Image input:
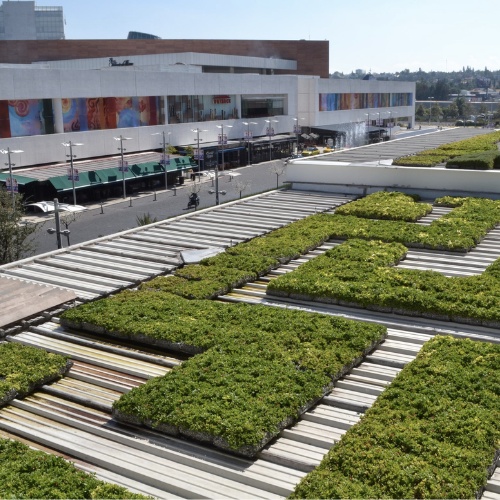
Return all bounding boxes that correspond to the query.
[0,54,415,166]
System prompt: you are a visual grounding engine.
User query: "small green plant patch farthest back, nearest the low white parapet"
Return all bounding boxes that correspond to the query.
[335,191,432,222]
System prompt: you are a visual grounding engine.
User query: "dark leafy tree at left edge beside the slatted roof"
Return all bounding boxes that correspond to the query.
[0,187,43,265]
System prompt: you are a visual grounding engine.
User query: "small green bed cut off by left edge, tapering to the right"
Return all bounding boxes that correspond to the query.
[0,342,73,406]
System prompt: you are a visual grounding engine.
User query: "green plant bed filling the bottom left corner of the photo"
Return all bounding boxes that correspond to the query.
[0,439,148,499]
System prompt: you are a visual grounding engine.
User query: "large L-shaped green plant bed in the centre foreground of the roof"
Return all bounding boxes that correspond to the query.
[63,291,387,456]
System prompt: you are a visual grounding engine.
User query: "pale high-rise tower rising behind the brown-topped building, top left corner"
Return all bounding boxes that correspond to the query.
[0,1,64,40]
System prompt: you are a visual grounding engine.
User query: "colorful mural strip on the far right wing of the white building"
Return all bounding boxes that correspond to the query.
[319,93,413,111]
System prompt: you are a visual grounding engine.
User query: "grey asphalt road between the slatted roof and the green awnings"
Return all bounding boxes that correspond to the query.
[31,160,286,255]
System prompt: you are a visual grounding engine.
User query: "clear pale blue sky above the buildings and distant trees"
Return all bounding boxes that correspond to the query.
[37,0,500,73]
